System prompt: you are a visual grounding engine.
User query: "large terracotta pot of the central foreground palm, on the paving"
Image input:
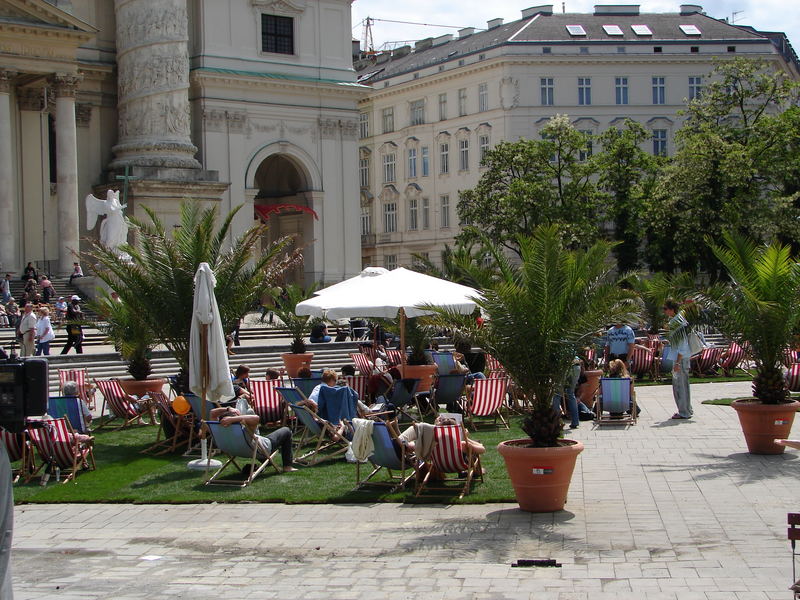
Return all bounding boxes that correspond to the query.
[497,439,583,512]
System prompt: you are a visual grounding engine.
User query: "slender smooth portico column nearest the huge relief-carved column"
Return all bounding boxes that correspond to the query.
[53,74,80,276]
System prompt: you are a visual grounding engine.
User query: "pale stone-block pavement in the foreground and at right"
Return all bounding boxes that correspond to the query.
[7,383,800,600]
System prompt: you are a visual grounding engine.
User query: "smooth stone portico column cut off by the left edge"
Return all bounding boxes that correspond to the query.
[0,71,20,277]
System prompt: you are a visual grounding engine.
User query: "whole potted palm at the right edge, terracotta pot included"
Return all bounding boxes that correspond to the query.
[702,233,800,454]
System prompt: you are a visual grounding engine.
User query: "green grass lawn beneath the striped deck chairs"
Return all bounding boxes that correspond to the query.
[14,417,523,504]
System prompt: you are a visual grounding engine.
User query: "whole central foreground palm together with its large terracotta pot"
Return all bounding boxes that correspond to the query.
[426,226,637,512]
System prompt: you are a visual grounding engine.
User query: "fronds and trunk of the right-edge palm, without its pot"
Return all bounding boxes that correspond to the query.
[703,233,800,404]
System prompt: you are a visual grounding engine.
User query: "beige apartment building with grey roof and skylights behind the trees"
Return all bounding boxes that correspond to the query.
[357,5,800,268]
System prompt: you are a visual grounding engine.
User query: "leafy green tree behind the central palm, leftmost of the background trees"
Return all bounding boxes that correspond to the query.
[457,115,599,255]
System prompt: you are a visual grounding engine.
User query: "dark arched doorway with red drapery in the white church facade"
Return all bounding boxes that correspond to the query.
[254,154,316,285]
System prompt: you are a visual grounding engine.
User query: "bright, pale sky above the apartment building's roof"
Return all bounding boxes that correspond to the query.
[353,0,800,53]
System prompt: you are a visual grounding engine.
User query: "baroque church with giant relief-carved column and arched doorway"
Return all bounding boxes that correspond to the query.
[0,0,366,282]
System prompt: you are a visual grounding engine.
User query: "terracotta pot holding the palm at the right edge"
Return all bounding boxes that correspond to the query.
[731,398,800,454]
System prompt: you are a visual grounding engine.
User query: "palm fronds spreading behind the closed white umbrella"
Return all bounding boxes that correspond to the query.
[84,201,301,390]
